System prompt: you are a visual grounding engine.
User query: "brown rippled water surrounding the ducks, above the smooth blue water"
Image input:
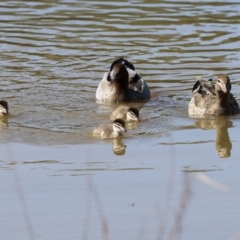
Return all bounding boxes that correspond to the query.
[0,1,240,143]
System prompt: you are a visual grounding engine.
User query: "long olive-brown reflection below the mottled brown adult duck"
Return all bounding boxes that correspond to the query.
[195,117,232,158]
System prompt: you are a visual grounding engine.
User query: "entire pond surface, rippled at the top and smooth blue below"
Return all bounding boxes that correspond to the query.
[0,0,240,240]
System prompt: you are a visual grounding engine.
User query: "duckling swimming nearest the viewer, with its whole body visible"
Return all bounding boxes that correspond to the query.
[93,118,127,138]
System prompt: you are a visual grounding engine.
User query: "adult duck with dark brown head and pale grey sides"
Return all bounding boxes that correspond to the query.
[96,58,151,102]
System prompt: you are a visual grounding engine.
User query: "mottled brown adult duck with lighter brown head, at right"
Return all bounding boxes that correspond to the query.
[188,74,240,116]
